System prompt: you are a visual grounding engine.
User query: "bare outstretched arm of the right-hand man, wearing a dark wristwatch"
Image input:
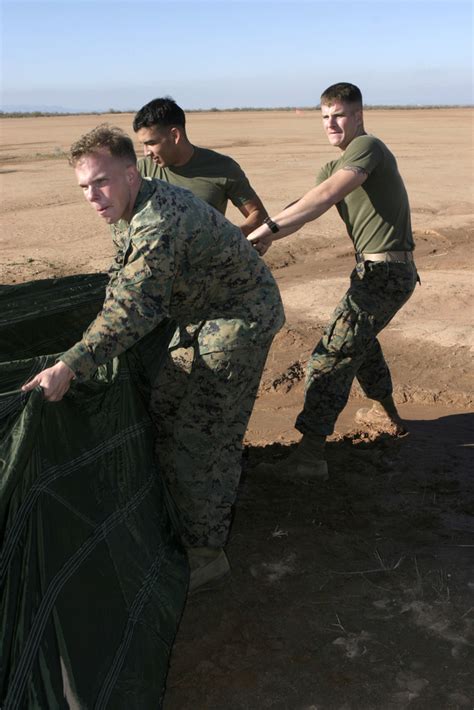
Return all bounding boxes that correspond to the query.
[247,167,367,254]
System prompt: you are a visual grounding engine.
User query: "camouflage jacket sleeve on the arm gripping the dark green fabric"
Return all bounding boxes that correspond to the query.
[60,228,174,380]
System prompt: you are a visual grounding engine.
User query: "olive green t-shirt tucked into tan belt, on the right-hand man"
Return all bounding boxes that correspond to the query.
[316,135,414,254]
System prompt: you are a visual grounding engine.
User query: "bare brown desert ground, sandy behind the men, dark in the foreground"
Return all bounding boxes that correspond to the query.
[0,109,474,710]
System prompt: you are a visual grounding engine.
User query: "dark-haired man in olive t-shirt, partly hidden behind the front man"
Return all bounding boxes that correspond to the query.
[133,97,267,235]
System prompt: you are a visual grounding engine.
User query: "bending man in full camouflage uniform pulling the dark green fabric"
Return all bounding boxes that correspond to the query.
[24,126,284,589]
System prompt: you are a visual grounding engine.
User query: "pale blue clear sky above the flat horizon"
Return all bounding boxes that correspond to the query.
[0,0,473,111]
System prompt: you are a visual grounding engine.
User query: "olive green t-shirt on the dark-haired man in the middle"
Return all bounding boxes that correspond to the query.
[138,146,257,214]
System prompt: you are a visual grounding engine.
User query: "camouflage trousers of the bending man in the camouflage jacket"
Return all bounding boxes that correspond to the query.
[151,338,272,547]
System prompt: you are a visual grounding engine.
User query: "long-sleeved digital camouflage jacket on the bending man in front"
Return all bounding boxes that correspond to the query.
[61,179,284,380]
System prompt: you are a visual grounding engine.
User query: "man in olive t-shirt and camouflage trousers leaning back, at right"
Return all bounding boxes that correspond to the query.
[249,83,418,479]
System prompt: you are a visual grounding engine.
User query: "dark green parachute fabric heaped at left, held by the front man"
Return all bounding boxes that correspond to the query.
[0,274,188,710]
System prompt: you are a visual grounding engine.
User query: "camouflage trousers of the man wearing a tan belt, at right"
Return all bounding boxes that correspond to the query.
[295,262,418,436]
